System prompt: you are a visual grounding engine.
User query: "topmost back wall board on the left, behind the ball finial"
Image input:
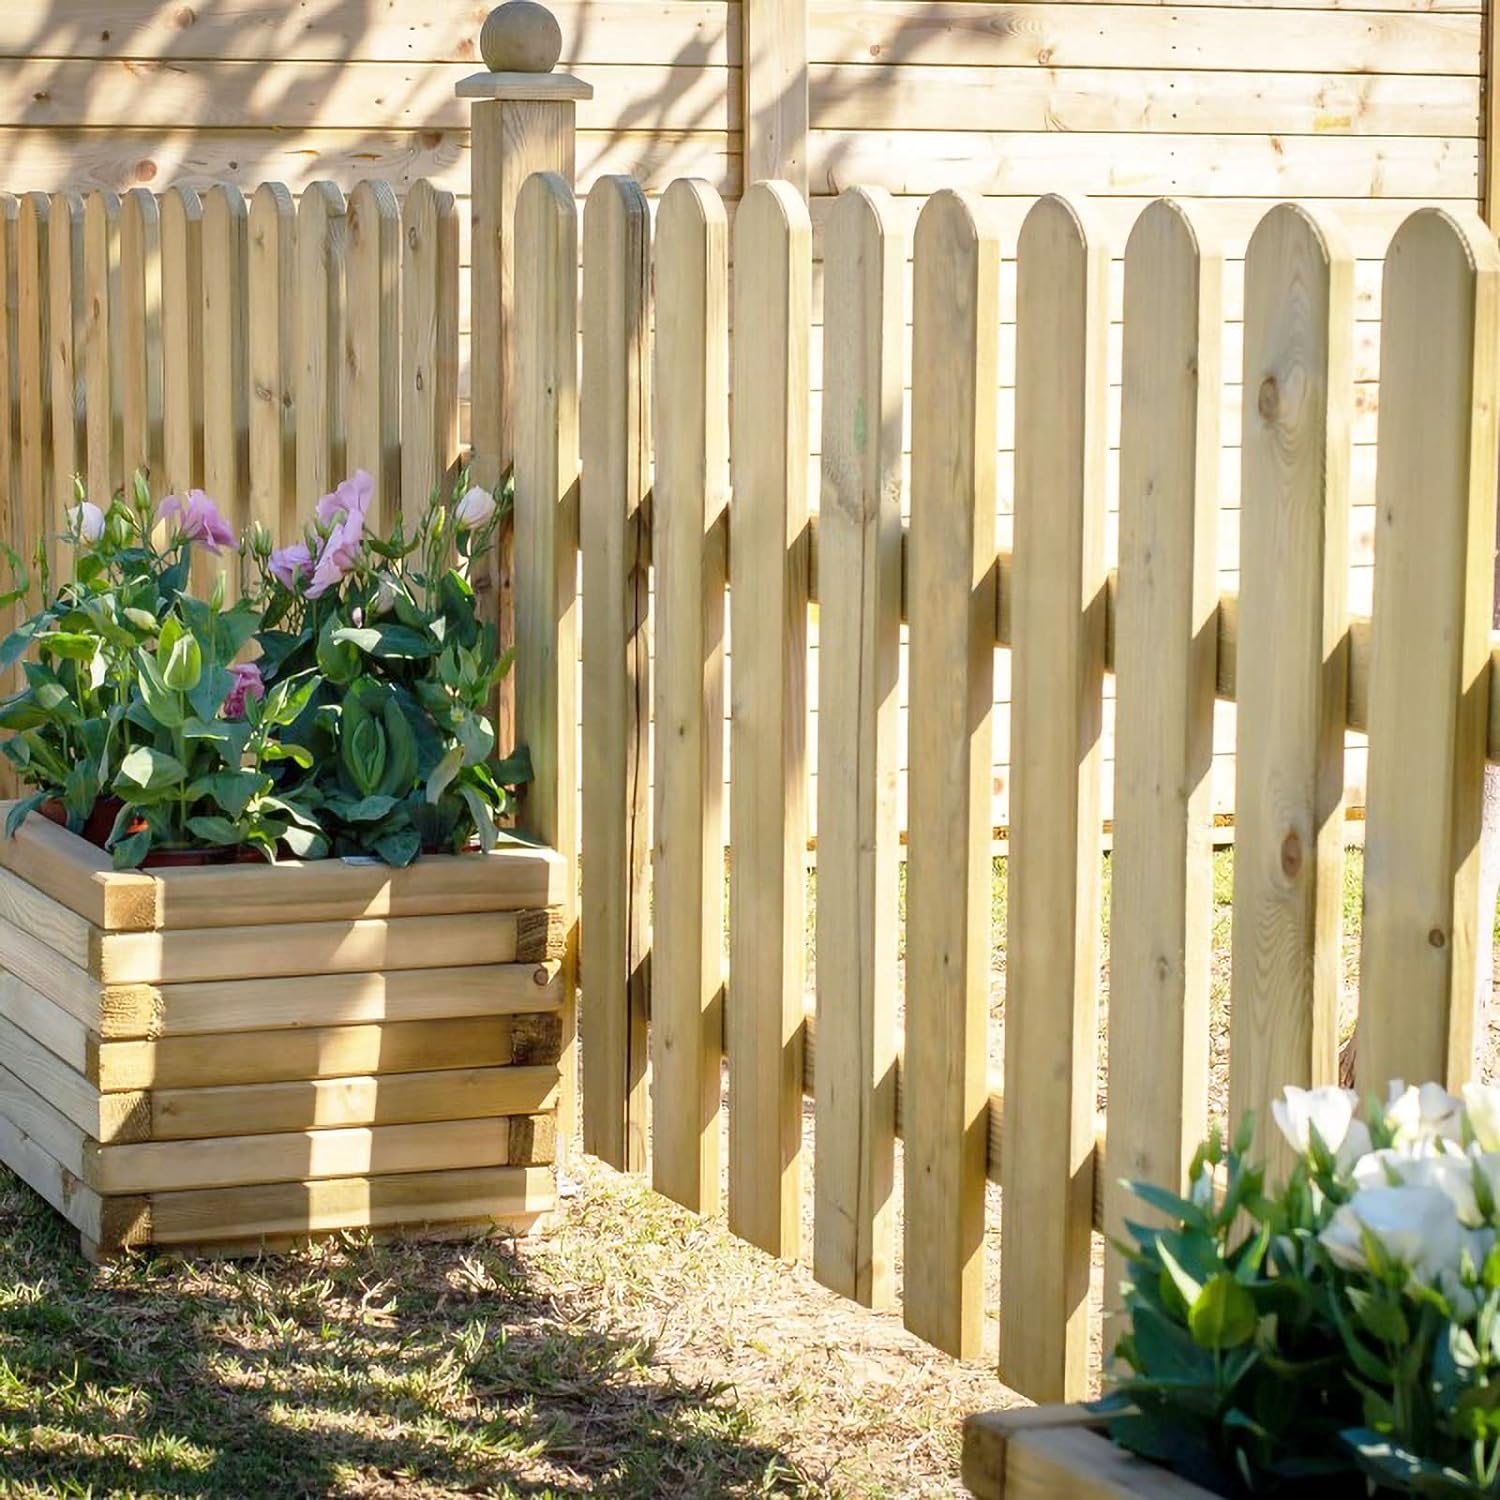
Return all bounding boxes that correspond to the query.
[0,0,740,63]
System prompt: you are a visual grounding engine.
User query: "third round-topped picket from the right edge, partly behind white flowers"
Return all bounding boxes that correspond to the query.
[1104,201,1224,1358]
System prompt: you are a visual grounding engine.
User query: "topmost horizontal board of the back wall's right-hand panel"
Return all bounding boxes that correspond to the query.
[809,0,1481,77]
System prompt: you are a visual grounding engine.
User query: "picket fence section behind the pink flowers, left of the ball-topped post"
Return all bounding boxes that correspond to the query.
[0,182,459,554]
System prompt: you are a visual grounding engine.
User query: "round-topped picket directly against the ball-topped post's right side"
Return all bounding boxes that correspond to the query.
[516,173,579,1160]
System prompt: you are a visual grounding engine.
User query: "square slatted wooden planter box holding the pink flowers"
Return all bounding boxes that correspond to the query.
[0,804,566,1256]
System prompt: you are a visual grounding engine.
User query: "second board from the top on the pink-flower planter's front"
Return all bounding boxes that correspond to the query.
[95,908,546,984]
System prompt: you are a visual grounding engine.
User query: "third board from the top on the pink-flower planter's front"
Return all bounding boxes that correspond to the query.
[141,960,563,1037]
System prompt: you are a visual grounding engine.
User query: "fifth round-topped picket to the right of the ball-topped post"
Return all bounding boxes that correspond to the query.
[813,188,908,1307]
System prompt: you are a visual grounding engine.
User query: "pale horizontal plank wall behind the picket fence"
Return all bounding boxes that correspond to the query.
[0,0,1485,824]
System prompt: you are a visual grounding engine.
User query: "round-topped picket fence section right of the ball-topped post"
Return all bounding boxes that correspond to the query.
[531,176,1500,1400]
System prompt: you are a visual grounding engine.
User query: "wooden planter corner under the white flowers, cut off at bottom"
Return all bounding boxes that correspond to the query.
[963,1406,1223,1500]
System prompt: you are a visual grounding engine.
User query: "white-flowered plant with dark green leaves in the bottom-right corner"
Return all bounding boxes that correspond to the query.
[1101,1083,1500,1497]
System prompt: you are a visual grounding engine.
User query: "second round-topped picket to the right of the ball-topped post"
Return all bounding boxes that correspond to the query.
[579,177,651,1172]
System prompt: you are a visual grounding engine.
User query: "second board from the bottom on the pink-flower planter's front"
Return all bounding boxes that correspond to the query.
[93,1119,509,1194]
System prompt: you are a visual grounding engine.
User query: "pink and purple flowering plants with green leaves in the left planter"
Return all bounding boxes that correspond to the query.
[0,474,530,867]
